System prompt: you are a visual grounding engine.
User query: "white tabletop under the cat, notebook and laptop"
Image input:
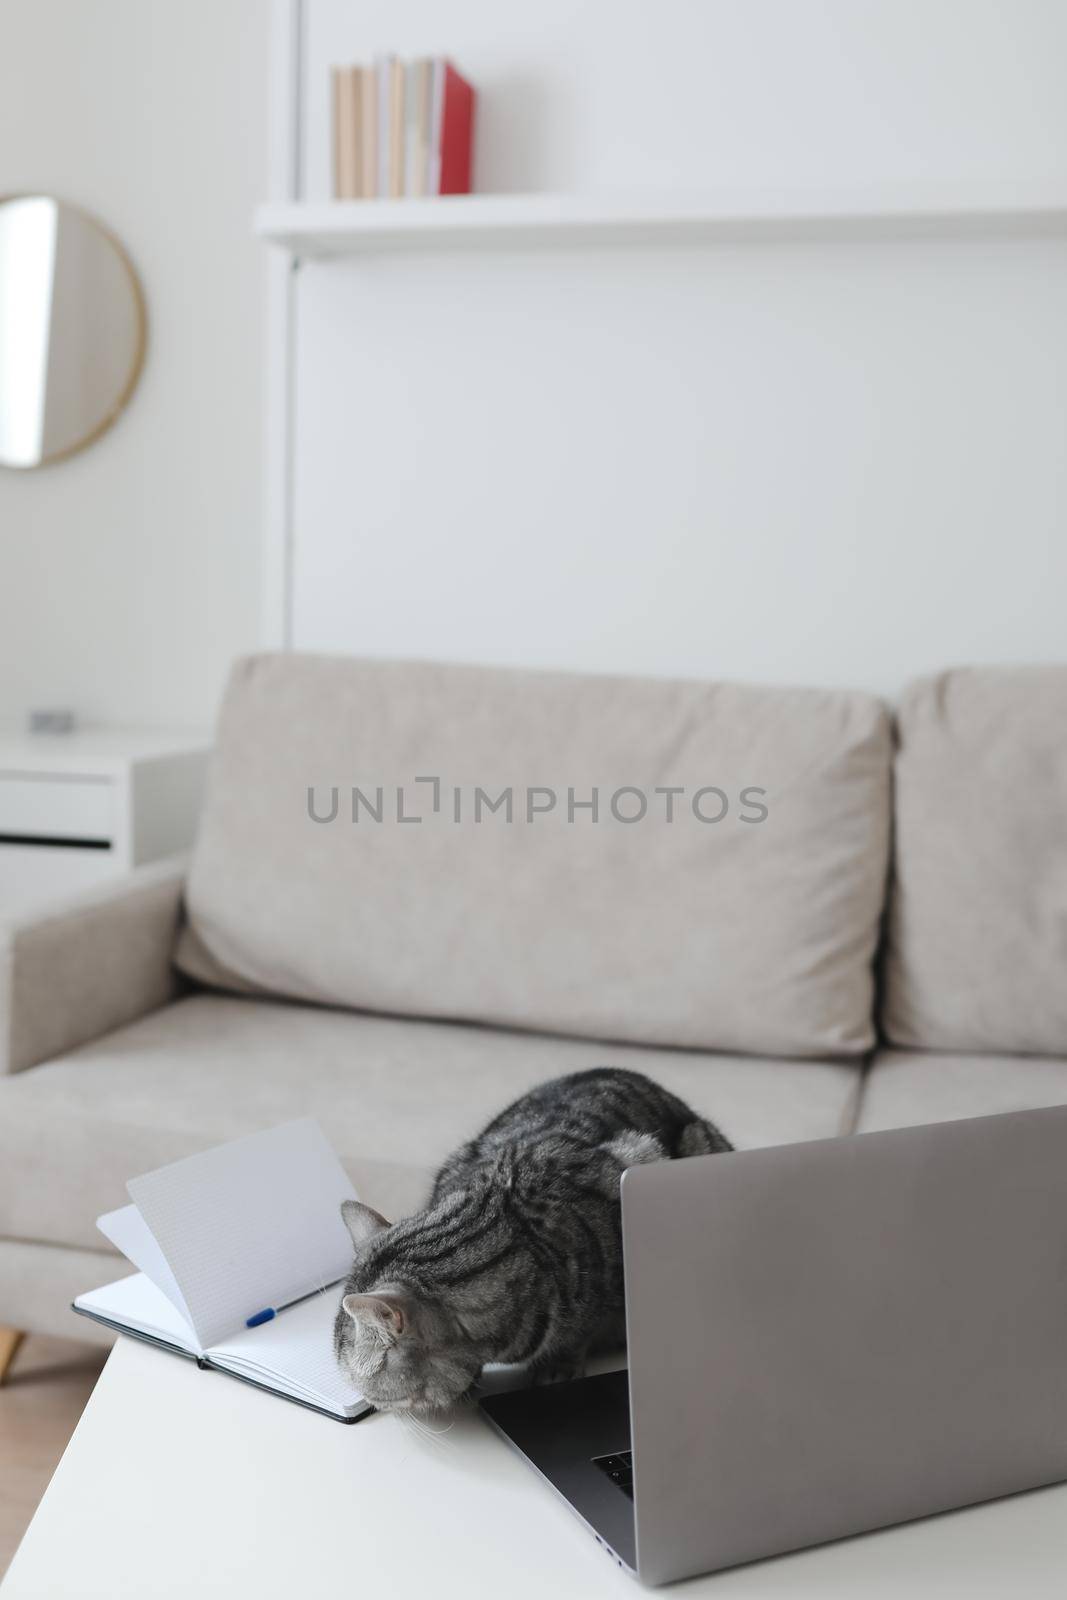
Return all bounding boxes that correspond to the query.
[0,1339,1067,1600]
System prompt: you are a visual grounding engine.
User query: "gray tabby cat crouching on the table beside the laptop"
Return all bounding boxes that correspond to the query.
[334,1067,733,1414]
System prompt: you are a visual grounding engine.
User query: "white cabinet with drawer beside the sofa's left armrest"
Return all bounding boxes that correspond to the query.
[0,728,208,920]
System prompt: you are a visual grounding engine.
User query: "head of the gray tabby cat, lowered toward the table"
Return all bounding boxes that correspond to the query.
[334,1200,482,1416]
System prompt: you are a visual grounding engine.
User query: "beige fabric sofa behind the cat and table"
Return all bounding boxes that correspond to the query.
[0,656,1067,1334]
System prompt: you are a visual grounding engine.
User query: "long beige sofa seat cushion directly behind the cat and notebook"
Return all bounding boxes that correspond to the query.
[0,995,861,1248]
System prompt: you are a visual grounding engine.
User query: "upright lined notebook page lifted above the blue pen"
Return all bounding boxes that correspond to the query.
[126,1117,355,1349]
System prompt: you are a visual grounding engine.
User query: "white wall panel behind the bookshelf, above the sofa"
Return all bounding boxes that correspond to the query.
[293,0,1067,691]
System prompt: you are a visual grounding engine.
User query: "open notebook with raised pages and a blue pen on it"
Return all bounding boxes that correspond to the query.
[74,1118,371,1422]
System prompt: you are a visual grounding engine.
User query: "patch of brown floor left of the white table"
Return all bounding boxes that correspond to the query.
[0,1334,107,1576]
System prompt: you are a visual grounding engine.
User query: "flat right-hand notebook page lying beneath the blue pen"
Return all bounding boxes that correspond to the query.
[208,1285,366,1414]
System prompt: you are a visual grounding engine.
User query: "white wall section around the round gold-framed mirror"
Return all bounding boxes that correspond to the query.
[0,0,269,726]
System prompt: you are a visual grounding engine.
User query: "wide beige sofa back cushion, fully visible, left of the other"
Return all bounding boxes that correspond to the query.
[179,654,889,1056]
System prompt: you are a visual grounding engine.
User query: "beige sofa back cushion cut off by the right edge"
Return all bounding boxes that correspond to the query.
[885,666,1067,1054]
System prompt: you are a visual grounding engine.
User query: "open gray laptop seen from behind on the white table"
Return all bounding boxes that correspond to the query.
[482,1106,1067,1584]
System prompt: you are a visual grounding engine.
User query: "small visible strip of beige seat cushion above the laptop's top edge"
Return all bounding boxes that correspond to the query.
[856,1050,1067,1133]
